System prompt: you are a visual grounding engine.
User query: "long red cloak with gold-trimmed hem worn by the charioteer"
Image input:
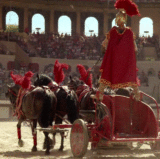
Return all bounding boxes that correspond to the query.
[100,27,137,89]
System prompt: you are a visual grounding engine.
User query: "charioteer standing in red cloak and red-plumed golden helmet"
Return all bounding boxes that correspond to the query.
[92,0,140,101]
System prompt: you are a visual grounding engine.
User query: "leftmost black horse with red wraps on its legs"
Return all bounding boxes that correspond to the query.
[6,85,57,154]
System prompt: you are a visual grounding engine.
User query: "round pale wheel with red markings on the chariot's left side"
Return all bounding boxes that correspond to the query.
[70,119,89,157]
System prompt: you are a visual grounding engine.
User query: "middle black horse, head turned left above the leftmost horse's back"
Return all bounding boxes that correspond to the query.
[34,74,79,150]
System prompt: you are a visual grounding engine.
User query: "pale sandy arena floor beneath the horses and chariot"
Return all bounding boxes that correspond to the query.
[0,121,156,159]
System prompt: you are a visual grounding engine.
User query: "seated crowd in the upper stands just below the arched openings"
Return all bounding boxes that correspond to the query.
[0,32,160,60]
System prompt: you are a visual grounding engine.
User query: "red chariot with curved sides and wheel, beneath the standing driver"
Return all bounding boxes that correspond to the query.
[70,92,160,157]
